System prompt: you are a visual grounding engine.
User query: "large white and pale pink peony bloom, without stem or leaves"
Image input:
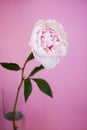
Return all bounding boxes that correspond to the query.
[29,19,68,69]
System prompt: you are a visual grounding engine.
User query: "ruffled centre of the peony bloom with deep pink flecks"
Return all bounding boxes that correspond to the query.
[37,26,59,52]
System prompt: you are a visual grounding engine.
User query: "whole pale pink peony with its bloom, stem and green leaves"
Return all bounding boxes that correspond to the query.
[0,19,68,130]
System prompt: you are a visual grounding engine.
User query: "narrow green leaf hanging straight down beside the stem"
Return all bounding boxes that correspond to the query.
[24,78,32,102]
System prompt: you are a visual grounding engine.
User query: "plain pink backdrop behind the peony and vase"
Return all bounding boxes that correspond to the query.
[0,0,87,130]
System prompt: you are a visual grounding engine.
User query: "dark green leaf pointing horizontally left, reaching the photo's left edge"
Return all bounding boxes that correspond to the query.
[0,63,21,71]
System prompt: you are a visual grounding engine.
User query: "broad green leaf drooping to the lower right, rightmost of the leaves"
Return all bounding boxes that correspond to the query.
[32,78,53,97]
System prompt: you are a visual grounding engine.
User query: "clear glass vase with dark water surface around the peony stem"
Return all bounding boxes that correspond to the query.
[2,88,25,130]
